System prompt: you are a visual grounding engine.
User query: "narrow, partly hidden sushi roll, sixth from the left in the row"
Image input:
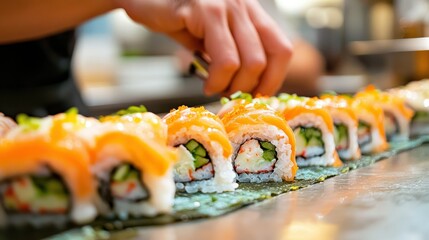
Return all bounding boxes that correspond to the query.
[321,95,361,160]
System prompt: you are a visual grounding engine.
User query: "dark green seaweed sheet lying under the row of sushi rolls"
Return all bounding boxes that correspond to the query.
[0,136,429,240]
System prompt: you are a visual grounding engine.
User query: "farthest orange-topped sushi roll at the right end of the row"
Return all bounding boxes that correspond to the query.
[355,85,414,140]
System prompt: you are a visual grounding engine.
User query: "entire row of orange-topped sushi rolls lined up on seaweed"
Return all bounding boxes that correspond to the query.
[0,84,413,226]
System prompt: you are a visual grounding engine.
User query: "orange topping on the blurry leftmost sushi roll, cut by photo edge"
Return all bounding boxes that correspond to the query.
[0,135,93,201]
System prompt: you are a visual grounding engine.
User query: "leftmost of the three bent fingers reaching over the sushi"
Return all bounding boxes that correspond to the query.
[203,1,240,95]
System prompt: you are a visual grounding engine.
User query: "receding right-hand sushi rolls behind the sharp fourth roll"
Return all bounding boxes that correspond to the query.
[219,85,414,167]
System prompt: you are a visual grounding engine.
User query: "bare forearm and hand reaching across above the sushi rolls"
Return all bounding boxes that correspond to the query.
[0,0,292,95]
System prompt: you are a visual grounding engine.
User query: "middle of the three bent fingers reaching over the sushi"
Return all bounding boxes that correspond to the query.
[226,1,267,95]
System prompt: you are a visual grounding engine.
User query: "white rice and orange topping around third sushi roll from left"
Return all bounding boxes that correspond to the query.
[168,126,238,193]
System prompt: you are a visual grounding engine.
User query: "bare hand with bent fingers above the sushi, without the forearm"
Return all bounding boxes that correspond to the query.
[116,0,292,95]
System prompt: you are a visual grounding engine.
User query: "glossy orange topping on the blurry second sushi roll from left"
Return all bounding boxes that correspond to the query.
[93,112,177,175]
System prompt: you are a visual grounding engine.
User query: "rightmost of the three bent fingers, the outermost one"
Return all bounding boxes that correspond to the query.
[242,1,292,95]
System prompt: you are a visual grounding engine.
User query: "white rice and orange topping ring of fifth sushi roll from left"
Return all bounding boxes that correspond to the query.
[288,113,336,167]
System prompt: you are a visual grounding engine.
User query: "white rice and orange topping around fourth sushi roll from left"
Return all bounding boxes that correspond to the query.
[228,124,294,182]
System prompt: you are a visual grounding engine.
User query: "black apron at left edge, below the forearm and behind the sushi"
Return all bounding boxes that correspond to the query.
[0,30,87,117]
